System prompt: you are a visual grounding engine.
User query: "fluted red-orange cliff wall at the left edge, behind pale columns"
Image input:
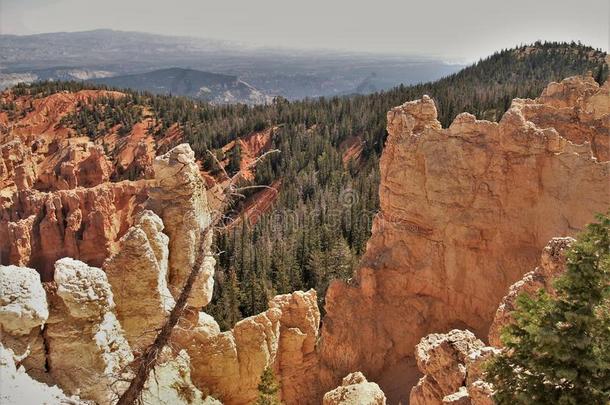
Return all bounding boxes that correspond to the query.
[0,181,146,281]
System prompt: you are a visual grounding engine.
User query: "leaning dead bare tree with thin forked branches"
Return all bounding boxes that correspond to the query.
[117,149,279,405]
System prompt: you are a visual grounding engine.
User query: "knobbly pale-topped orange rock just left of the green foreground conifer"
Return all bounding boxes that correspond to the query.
[409,329,498,405]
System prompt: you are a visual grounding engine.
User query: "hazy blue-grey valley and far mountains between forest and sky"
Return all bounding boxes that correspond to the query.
[0,30,463,104]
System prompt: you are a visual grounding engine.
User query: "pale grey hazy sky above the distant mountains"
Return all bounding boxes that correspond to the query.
[0,0,610,61]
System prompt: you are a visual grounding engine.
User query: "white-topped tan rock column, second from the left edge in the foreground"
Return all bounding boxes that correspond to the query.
[45,258,133,404]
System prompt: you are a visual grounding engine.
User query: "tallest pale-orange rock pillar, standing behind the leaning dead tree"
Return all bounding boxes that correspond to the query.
[149,144,216,308]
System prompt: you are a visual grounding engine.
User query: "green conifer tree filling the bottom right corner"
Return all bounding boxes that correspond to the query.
[487,215,610,405]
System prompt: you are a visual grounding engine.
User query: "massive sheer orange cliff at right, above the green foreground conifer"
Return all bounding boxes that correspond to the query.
[320,78,610,400]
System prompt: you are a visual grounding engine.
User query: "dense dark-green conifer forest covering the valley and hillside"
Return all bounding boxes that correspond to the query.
[7,43,608,328]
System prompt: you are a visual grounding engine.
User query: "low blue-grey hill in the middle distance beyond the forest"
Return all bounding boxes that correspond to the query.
[90,67,271,105]
